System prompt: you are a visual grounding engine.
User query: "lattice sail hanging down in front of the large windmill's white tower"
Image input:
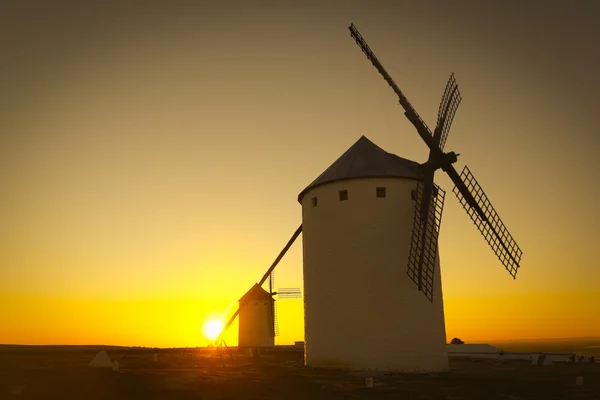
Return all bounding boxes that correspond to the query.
[406,182,446,302]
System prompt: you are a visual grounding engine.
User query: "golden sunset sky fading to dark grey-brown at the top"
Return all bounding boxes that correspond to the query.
[0,0,600,346]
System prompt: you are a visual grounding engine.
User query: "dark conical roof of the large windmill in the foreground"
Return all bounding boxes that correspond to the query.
[298,136,422,203]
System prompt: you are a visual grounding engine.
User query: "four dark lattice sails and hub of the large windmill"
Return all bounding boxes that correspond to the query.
[349,24,523,302]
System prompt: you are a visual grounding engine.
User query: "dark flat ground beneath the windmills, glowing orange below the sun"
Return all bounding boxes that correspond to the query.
[0,348,600,400]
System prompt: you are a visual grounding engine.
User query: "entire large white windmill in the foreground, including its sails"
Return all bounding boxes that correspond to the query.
[298,25,522,372]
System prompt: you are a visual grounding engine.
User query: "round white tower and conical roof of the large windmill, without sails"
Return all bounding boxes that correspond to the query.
[298,136,448,372]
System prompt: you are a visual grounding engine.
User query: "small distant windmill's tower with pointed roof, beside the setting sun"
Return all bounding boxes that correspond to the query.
[238,284,275,347]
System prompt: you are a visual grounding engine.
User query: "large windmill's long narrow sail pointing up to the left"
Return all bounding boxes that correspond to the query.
[348,24,434,148]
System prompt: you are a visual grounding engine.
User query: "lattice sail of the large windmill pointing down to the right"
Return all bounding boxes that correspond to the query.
[453,165,523,278]
